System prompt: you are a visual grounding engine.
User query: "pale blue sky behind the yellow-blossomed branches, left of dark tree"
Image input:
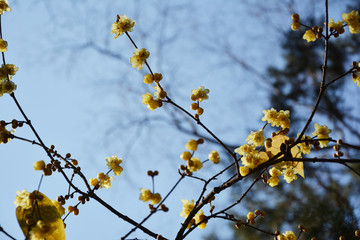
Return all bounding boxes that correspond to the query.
[0,0,356,239]
